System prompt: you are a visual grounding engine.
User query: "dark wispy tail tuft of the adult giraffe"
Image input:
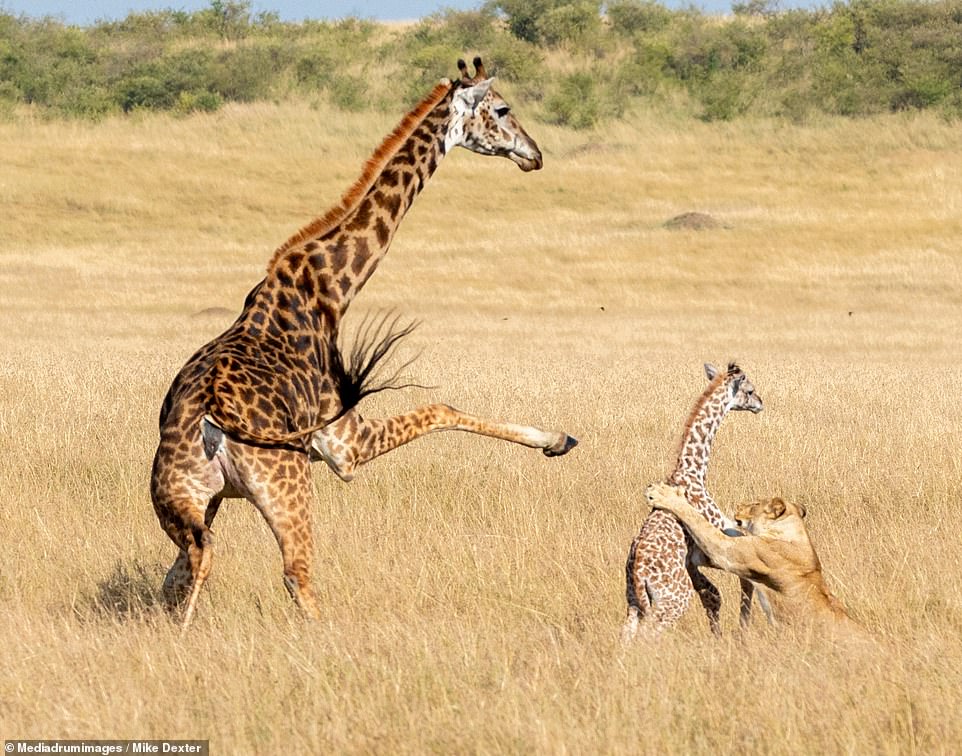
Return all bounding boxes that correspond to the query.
[330,312,427,413]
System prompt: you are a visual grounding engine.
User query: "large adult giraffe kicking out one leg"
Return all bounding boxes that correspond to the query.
[151,58,577,629]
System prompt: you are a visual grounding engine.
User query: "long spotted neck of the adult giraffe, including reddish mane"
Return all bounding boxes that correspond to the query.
[252,82,454,321]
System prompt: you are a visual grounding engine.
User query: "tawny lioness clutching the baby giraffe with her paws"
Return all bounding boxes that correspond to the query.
[645,483,863,634]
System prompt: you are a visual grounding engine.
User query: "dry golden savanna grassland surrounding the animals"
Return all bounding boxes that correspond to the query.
[0,91,962,754]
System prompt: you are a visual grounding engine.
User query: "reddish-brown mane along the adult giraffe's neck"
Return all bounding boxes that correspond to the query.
[268,79,457,269]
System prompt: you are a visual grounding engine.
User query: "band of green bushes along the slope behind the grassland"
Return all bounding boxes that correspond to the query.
[0,0,962,128]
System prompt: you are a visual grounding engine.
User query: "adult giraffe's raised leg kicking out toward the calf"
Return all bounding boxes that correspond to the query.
[311,404,578,481]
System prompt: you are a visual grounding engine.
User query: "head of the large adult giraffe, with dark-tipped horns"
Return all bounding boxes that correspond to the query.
[445,58,543,171]
